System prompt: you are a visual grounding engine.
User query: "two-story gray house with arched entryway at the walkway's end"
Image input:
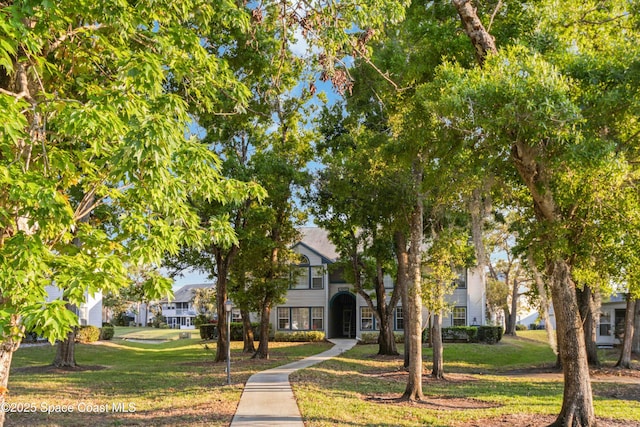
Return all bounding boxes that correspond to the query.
[270,227,486,338]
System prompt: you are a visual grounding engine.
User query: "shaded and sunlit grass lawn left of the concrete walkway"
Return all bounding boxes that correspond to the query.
[5,334,330,427]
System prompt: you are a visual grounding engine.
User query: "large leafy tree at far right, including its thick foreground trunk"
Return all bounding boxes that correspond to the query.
[429,2,638,426]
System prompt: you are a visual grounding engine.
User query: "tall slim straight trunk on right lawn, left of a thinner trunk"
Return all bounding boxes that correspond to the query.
[402,192,424,400]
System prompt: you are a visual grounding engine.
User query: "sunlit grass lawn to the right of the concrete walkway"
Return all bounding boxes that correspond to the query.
[291,331,640,427]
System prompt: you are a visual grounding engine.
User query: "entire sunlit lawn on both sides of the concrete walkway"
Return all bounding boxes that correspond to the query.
[6,328,640,427]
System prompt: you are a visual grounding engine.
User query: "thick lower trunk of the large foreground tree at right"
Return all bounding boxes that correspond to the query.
[549,260,596,427]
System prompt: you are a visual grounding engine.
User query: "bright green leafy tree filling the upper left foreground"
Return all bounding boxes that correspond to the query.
[0,0,256,418]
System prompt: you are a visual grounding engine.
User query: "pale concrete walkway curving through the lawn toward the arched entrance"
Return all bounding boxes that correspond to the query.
[231,339,356,427]
